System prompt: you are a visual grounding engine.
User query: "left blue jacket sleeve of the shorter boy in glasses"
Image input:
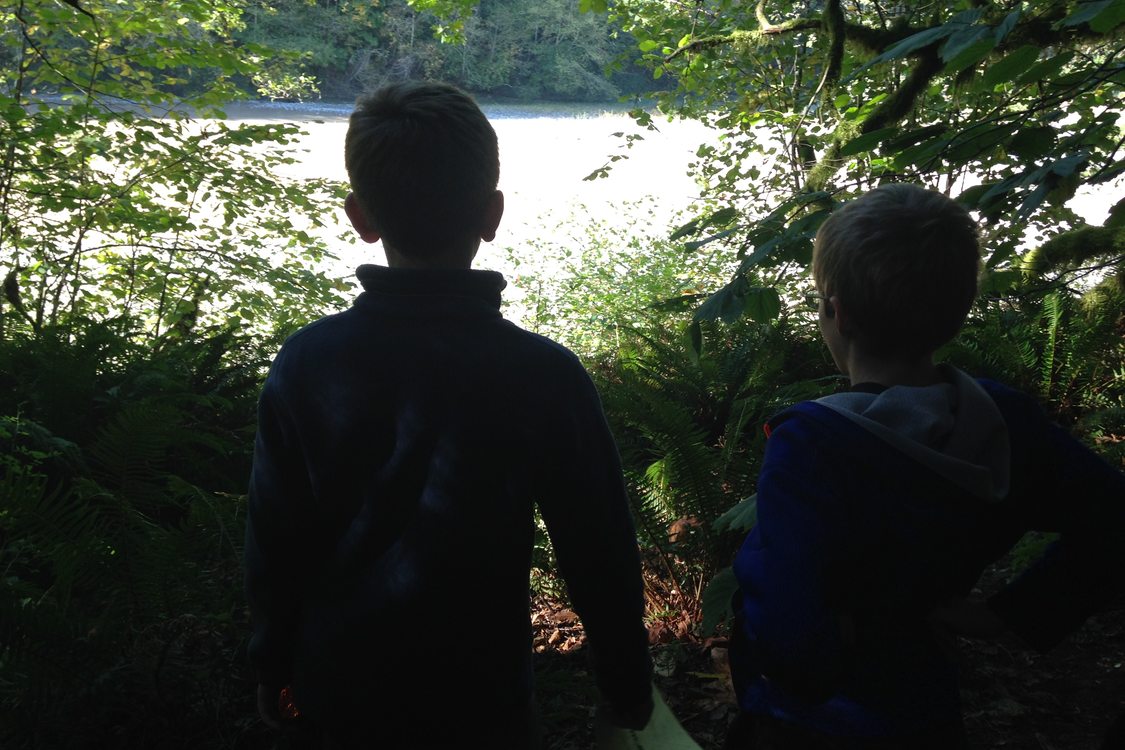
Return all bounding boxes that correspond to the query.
[735,417,848,703]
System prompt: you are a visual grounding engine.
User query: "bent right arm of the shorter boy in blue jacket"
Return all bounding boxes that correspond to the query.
[988,395,1125,651]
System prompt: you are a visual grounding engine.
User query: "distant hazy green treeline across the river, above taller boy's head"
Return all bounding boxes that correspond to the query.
[235,0,653,101]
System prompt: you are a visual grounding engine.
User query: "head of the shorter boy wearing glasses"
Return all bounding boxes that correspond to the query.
[812,183,980,358]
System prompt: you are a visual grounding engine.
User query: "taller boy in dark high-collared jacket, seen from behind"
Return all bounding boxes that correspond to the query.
[246,83,653,749]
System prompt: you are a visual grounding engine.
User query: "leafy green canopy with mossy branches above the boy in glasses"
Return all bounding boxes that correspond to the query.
[611,0,1125,337]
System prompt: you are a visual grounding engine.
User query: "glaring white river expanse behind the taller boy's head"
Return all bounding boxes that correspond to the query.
[226,102,716,273]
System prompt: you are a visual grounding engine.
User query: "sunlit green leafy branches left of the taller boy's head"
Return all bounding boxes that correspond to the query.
[0,0,341,337]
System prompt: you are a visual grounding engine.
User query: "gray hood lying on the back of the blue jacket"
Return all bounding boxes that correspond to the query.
[817,365,1010,501]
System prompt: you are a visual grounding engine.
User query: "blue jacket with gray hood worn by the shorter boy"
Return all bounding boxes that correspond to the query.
[731,368,1125,747]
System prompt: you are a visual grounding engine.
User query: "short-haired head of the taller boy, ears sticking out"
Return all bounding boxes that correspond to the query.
[344,82,500,257]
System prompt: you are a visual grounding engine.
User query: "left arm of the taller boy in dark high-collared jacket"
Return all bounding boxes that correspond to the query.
[245,377,312,696]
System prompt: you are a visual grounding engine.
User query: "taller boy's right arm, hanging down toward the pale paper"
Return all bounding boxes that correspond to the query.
[539,363,653,729]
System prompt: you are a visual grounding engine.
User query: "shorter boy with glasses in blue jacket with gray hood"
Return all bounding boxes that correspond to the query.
[728,184,1125,750]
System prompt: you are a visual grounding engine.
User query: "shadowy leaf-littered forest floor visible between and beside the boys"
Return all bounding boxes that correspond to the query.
[532,568,1125,750]
